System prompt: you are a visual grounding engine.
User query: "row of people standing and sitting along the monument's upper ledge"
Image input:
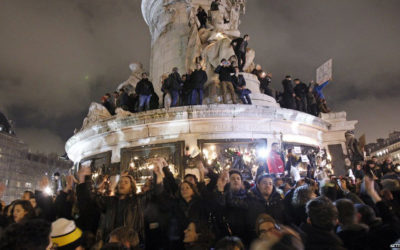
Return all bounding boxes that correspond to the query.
[101,61,330,116]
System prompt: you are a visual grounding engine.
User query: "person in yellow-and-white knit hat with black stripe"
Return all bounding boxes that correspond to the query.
[50,218,83,250]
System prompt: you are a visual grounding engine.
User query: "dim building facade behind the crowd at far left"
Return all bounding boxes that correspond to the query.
[0,112,72,204]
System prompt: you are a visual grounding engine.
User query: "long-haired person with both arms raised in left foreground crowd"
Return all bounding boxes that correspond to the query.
[76,158,167,240]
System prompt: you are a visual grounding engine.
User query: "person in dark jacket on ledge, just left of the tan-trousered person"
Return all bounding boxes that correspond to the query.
[190,63,208,105]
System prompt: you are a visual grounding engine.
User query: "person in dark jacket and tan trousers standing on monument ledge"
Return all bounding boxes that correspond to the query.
[215,58,236,104]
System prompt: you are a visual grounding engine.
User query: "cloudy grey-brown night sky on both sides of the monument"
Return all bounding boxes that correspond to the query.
[0,0,400,153]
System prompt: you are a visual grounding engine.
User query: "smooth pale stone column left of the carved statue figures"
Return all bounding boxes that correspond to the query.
[142,0,190,101]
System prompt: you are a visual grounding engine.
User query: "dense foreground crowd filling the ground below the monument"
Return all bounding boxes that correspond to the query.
[0,154,400,250]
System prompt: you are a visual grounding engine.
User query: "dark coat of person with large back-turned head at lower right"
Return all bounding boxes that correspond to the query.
[300,223,345,250]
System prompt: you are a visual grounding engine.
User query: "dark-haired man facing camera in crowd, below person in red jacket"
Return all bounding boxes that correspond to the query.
[248,174,285,238]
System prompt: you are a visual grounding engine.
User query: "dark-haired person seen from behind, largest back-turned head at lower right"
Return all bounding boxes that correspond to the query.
[300,196,345,250]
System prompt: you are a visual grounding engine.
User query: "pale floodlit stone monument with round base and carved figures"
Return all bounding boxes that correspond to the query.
[65,0,357,180]
